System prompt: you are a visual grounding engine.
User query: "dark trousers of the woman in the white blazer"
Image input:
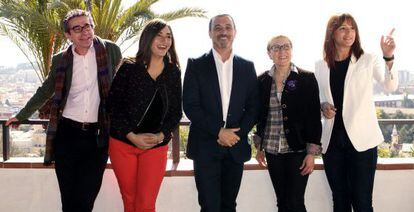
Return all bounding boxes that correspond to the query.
[323,130,377,212]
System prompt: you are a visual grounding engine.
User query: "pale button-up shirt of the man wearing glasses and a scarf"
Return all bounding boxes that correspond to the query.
[62,45,101,122]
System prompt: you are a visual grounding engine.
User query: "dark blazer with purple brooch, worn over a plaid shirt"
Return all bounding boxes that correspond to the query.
[256,68,322,150]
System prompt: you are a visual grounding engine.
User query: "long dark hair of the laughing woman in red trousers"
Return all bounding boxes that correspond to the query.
[135,19,180,67]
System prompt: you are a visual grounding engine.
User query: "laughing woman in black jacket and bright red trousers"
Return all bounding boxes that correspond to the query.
[108,19,182,212]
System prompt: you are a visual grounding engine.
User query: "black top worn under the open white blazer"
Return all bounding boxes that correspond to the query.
[329,57,351,130]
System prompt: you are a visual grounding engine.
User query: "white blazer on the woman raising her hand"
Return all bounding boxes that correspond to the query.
[315,53,398,153]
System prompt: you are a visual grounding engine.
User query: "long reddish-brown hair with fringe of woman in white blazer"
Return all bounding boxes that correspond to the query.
[323,13,364,69]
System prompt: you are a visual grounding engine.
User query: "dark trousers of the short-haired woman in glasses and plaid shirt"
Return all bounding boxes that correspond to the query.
[266,152,309,212]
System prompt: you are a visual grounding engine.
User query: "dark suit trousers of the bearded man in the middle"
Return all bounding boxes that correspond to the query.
[194,148,243,212]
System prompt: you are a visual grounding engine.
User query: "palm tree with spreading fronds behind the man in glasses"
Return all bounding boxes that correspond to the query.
[0,0,206,82]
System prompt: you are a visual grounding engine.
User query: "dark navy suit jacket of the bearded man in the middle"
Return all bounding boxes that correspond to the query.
[183,51,259,163]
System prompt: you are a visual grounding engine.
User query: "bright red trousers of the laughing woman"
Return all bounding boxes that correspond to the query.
[109,138,168,212]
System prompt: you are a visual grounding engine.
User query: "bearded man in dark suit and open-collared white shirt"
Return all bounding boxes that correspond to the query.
[183,14,259,212]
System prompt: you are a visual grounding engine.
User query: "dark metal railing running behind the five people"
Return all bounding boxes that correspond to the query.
[0,119,414,164]
